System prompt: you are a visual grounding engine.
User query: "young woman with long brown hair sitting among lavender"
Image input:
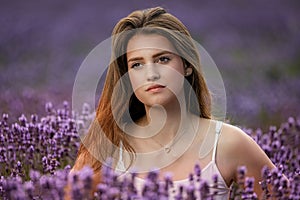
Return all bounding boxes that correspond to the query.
[73,7,274,199]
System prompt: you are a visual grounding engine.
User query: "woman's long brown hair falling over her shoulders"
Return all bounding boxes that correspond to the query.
[74,7,211,183]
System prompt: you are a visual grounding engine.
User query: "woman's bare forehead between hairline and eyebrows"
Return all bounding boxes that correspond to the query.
[127,34,177,54]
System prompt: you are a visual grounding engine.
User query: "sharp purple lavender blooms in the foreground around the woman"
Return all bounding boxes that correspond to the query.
[0,102,300,200]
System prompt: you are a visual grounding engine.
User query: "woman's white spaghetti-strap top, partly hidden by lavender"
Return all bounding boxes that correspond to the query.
[116,121,230,200]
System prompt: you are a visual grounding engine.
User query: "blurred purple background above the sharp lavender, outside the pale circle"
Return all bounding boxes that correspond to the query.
[0,0,300,128]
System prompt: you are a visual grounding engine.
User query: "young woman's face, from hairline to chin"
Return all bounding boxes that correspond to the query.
[127,34,184,106]
